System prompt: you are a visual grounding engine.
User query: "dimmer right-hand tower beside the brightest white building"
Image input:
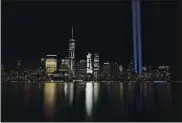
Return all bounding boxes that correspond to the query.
[93,53,99,78]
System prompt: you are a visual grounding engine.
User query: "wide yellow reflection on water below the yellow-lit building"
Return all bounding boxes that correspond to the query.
[44,83,56,119]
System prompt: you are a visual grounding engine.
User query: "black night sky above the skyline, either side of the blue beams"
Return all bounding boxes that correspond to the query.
[2,0,180,79]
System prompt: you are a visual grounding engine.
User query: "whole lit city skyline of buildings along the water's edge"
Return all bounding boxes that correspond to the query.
[1,27,170,81]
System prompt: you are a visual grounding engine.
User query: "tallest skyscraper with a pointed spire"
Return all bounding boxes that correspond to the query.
[68,27,75,75]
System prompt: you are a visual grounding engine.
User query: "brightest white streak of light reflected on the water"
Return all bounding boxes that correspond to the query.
[85,83,93,116]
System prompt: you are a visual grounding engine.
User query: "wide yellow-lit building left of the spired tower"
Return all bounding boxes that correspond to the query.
[45,55,57,74]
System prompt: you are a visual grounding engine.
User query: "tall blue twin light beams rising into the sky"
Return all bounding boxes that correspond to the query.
[132,0,142,73]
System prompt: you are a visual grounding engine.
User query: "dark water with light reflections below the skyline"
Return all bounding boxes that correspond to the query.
[1,83,182,122]
